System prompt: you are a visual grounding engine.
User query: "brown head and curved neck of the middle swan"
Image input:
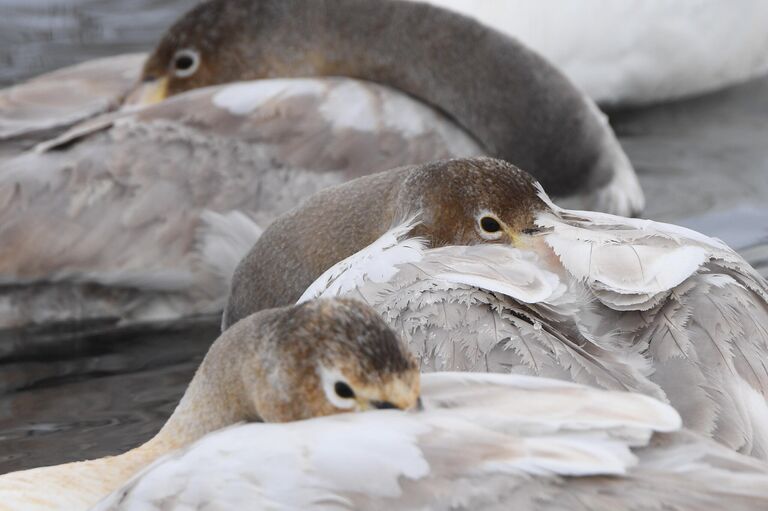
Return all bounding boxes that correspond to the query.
[223,158,548,328]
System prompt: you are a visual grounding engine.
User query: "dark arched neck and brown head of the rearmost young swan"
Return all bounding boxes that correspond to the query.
[134,0,642,206]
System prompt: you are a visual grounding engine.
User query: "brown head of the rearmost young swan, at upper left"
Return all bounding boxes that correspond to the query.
[125,0,327,105]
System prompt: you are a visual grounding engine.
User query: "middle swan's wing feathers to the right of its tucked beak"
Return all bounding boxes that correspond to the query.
[537,191,768,458]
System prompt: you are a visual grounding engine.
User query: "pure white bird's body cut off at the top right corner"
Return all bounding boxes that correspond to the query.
[422,0,768,105]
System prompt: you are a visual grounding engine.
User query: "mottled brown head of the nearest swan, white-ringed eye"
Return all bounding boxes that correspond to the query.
[212,299,419,422]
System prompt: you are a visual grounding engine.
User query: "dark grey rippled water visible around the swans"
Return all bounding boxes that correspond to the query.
[0,0,768,473]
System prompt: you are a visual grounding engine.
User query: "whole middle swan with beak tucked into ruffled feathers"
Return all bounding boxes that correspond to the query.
[223,158,768,459]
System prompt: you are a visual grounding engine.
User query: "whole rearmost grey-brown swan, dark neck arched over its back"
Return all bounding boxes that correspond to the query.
[0,0,643,328]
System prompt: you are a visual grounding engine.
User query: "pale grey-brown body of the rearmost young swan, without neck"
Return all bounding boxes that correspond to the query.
[0,79,481,328]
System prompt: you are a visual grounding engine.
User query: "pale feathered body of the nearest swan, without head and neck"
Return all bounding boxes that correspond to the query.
[94,373,768,511]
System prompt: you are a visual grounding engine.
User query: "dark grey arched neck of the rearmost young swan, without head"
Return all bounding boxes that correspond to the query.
[241,0,613,195]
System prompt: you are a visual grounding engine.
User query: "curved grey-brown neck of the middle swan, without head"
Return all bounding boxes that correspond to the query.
[223,167,413,328]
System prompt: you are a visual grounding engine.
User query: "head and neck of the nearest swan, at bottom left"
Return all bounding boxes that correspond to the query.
[0,300,420,511]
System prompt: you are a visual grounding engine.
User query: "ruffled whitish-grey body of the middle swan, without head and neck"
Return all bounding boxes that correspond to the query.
[304,191,768,458]
